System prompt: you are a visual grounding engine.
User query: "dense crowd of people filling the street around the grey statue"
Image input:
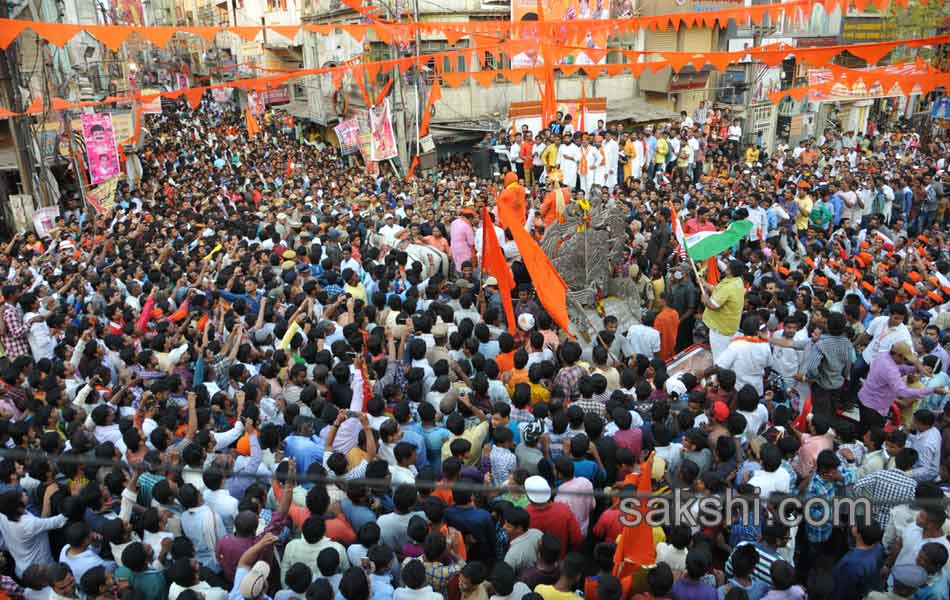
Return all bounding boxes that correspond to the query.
[0,91,950,600]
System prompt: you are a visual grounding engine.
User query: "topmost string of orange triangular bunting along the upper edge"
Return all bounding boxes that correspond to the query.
[0,0,909,52]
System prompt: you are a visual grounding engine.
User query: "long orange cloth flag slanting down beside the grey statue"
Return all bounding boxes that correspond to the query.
[498,180,570,332]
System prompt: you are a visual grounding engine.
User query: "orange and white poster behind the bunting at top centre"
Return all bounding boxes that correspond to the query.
[511,0,608,69]
